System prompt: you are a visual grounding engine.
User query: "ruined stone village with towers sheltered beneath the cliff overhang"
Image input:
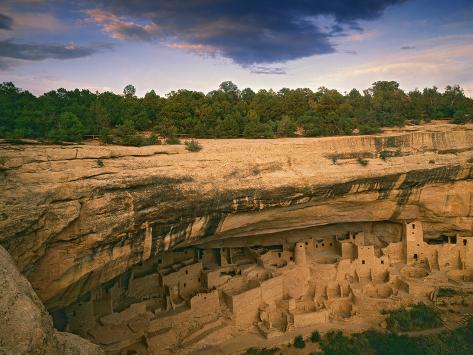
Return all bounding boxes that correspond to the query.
[53,220,473,354]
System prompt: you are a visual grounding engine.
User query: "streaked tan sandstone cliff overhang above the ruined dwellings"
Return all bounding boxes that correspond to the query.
[0,124,473,309]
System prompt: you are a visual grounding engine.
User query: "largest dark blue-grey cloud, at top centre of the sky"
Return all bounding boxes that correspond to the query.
[89,0,405,66]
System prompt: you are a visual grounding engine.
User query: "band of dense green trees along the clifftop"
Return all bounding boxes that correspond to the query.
[0,81,473,145]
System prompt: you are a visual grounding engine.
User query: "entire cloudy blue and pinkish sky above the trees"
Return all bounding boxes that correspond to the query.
[0,0,473,97]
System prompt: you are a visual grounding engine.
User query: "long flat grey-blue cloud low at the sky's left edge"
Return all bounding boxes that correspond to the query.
[0,40,110,68]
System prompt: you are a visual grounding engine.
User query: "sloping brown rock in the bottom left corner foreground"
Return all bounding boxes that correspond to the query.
[0,246,104,355]
